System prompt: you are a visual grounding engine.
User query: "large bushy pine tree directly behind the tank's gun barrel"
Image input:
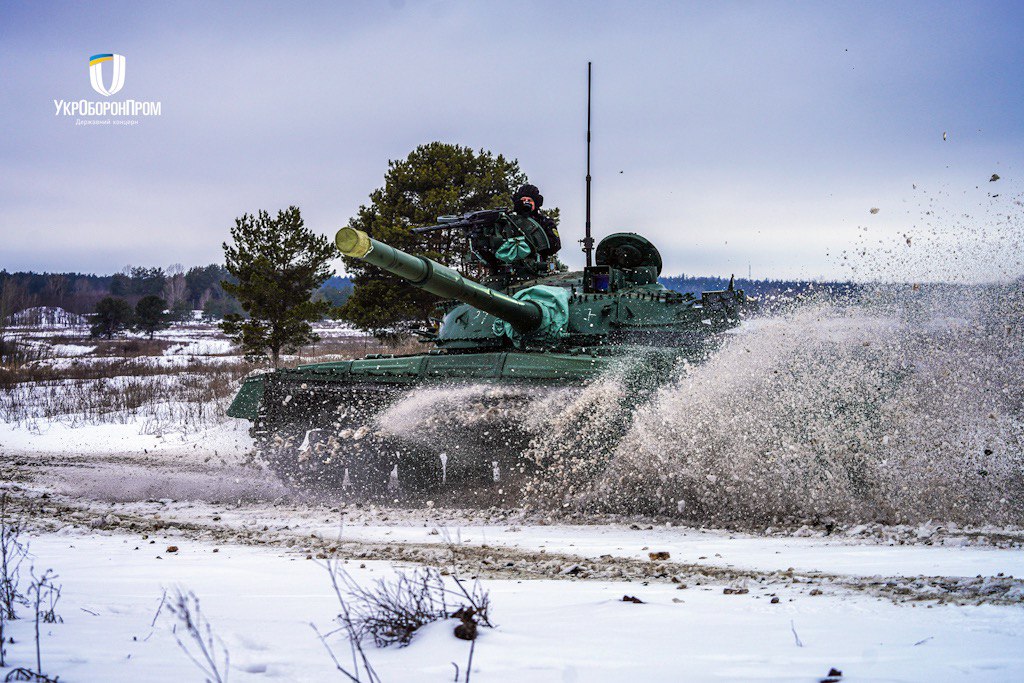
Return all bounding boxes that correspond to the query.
[341,142,526,339]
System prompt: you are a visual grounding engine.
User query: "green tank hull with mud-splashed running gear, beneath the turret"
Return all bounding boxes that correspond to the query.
[228,351,622,504]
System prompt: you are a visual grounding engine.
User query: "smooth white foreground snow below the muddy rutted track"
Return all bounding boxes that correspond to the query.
[8,532,1024,682]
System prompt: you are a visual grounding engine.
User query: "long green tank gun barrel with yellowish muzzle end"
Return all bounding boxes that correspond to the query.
[335,227,544,334]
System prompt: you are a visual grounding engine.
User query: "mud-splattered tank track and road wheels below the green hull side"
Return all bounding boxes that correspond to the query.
[251,380,531,501]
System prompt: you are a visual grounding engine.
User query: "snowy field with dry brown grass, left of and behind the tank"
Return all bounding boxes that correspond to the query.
[0,328,423,434]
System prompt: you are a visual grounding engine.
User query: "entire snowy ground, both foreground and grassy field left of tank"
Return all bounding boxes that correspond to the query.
[0,317,1024,682]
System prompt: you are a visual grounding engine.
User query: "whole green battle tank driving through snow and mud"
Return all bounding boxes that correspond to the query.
[227,211,752,497]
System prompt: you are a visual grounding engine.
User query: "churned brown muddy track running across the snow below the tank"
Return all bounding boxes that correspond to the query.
[0,456,1024,604]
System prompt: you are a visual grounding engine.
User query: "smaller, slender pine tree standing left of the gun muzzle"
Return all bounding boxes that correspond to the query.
[220,206,338,368]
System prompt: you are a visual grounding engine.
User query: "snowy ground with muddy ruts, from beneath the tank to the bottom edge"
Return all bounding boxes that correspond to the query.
[3,449,1024,681]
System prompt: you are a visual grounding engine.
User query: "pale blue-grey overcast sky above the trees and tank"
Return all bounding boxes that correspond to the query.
[0,0,1024,280]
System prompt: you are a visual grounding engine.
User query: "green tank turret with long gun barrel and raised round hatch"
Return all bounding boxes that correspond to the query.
[335,227,745,352]
